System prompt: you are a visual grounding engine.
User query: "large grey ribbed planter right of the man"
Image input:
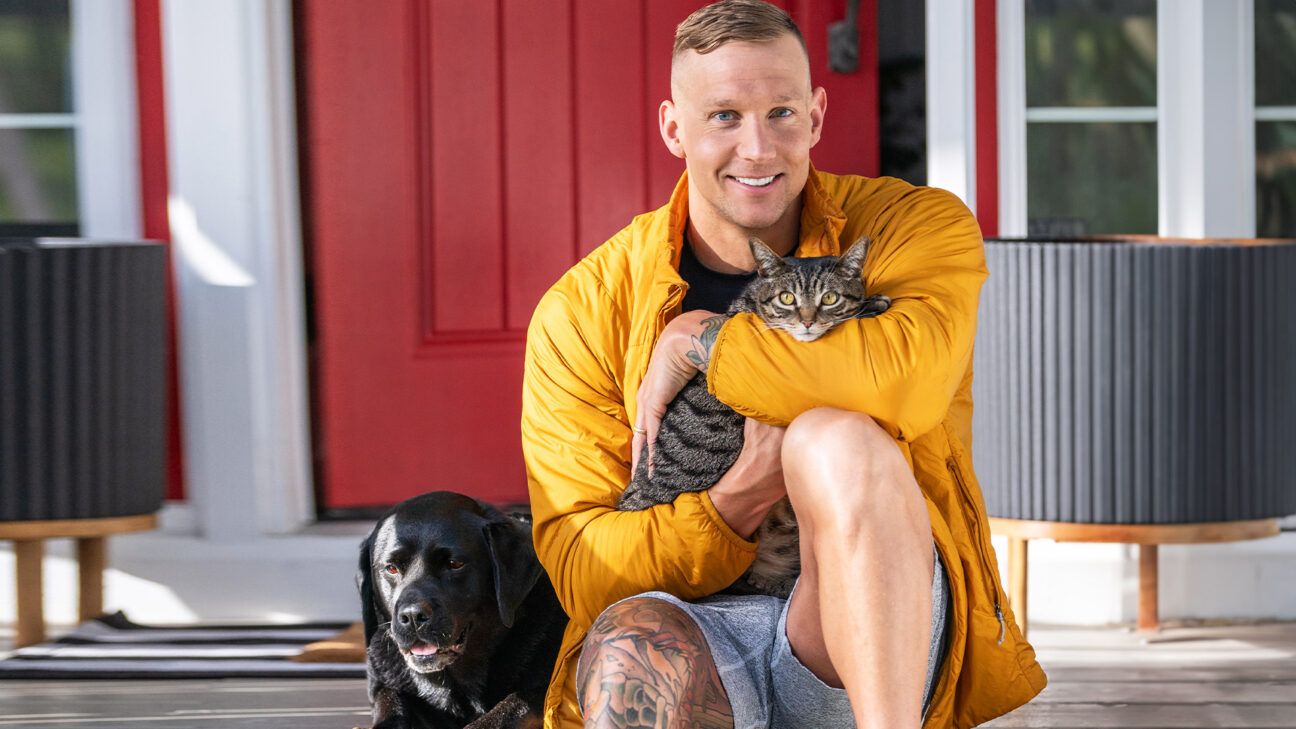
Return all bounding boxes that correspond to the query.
[973,239,1296,524]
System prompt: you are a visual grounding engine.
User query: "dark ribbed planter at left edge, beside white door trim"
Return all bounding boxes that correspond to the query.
[0,240,166,521]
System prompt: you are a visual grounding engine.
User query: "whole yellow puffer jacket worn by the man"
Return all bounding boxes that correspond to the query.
[522,169,1046,729]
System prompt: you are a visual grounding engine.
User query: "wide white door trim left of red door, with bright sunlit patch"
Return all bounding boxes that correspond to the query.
[162,0,314,541]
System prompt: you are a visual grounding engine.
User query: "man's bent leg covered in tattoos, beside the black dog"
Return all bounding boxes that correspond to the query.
[577,598,734,729]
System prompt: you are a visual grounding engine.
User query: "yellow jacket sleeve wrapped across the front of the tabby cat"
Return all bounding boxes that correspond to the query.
[708,188,986,441]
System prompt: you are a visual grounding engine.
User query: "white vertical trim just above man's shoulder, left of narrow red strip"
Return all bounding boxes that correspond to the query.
[927,0,976,213]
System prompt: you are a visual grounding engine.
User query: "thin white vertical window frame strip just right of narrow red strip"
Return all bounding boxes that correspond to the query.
[995,0,1026,236]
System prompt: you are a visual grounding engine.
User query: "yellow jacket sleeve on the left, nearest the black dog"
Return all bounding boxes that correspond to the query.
[522,288,756,627]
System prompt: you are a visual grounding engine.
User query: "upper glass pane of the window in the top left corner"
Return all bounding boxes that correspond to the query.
[0,0,73,114]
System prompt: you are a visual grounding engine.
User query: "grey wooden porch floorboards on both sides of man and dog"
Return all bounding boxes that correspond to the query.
[0,623,1296,729]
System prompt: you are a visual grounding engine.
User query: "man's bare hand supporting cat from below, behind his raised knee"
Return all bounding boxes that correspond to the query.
[710,418,788,540]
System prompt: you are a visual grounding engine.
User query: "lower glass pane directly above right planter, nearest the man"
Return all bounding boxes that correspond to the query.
[1026,123,1156,236]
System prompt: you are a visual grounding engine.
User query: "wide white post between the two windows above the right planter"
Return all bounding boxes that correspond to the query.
[1156,0,1256,237]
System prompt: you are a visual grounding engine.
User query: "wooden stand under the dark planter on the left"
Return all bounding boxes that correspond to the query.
[0,514,158,647]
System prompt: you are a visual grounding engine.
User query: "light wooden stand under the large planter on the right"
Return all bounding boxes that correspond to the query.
[990,518,1278,634]
